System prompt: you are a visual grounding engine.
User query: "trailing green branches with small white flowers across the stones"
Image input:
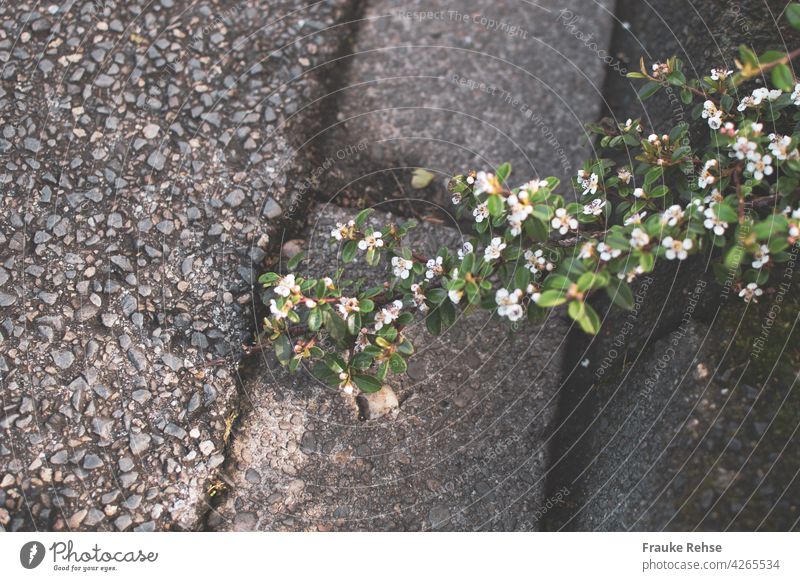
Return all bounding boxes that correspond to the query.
[259,9,800,393]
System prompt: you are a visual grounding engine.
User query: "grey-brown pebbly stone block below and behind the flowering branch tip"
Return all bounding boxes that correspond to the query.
[209,207,568,530]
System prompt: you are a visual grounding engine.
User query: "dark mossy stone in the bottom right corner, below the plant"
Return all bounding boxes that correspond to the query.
[559,307,800,531]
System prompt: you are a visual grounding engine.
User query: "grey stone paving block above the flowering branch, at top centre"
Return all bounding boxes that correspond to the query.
[316,0,613,214]
